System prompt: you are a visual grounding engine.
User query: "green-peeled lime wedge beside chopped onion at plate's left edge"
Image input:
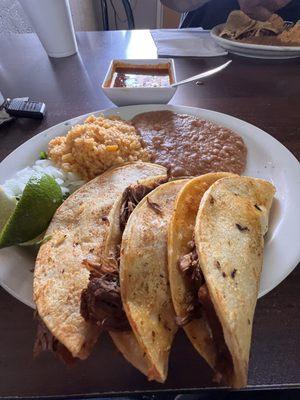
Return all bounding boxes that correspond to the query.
[0,174,63,248]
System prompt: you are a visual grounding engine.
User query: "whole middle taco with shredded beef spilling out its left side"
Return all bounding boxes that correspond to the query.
[81,176,183,382]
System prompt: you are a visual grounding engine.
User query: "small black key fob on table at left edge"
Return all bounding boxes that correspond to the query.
[4,99,46,119]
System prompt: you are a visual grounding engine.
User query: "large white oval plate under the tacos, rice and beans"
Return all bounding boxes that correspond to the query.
[0,105,300,307]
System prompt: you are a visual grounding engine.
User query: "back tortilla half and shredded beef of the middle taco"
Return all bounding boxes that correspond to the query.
[81,174,167,380]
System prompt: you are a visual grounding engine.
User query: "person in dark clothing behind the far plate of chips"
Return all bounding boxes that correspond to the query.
[161,0,300,29]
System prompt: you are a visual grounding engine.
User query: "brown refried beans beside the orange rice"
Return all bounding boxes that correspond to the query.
[131,110,247,177]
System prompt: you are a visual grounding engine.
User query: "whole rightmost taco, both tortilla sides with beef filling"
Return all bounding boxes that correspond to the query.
[168,173,275,387]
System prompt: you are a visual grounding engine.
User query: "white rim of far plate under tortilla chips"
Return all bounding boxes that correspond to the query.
[211,24,300,59]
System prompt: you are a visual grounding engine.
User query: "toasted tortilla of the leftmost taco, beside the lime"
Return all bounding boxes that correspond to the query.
[33,162,166,359]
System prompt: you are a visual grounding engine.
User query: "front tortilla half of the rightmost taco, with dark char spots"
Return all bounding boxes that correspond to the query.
[194,177,275,388]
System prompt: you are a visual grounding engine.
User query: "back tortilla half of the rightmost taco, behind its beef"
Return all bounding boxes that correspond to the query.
[168,172,232,367]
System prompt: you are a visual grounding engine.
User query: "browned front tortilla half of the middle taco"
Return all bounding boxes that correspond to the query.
[120,180,186,382]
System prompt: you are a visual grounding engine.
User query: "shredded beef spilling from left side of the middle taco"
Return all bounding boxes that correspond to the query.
[80,179,166,331]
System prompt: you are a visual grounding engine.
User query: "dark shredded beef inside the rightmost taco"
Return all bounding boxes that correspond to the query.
[177,241,233,377]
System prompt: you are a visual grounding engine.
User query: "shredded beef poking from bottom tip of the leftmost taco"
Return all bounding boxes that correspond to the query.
[33,316,76,365]
